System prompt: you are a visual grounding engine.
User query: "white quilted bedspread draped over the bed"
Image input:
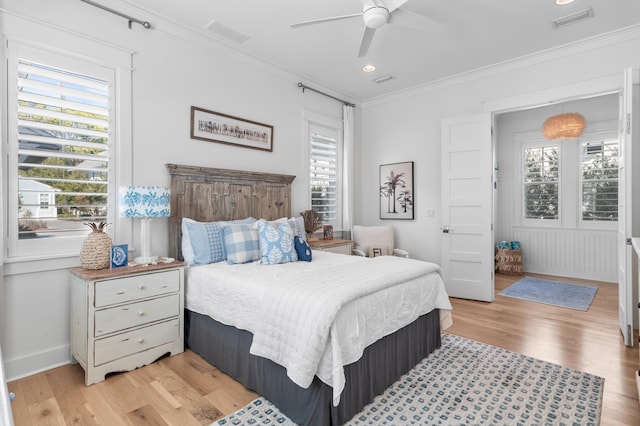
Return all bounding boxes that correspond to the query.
[186,251,451,405]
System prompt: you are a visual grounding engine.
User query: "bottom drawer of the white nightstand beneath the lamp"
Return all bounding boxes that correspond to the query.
[94,318,180,366]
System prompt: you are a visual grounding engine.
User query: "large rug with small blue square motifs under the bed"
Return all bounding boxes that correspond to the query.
[213,334,604,426]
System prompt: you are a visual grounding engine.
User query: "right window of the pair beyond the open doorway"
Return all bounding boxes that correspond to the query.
[580,139,618,221]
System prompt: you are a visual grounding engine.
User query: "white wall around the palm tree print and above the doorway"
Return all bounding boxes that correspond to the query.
[354,28,640,270]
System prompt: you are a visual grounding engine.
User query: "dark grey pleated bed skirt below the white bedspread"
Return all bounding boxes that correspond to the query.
[185,309,441,426]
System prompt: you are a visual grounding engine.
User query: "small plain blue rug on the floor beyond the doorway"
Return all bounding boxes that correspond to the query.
[500,277,598,311]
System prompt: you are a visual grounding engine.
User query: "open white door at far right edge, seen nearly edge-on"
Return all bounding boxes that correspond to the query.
[617,69,640,346]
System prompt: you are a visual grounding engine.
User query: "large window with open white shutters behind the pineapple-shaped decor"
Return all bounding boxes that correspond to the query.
[6,43,120,257]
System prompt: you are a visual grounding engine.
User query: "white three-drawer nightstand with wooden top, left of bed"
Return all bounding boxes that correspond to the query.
[70,262,184,386]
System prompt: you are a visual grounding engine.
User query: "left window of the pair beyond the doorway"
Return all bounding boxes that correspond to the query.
[522,145,560,220]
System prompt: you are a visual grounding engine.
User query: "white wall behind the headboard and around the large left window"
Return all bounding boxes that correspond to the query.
[0,0,350,380]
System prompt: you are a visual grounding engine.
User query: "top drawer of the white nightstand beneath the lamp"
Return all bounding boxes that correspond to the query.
[95,270,180,308]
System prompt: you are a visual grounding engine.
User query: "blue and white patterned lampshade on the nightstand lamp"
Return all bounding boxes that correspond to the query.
[120,186,171,218]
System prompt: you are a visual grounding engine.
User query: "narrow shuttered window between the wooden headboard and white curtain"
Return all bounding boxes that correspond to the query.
[308,122,342,229]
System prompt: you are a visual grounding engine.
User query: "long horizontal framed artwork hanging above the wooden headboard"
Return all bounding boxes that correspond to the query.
[191,106,273,152]
